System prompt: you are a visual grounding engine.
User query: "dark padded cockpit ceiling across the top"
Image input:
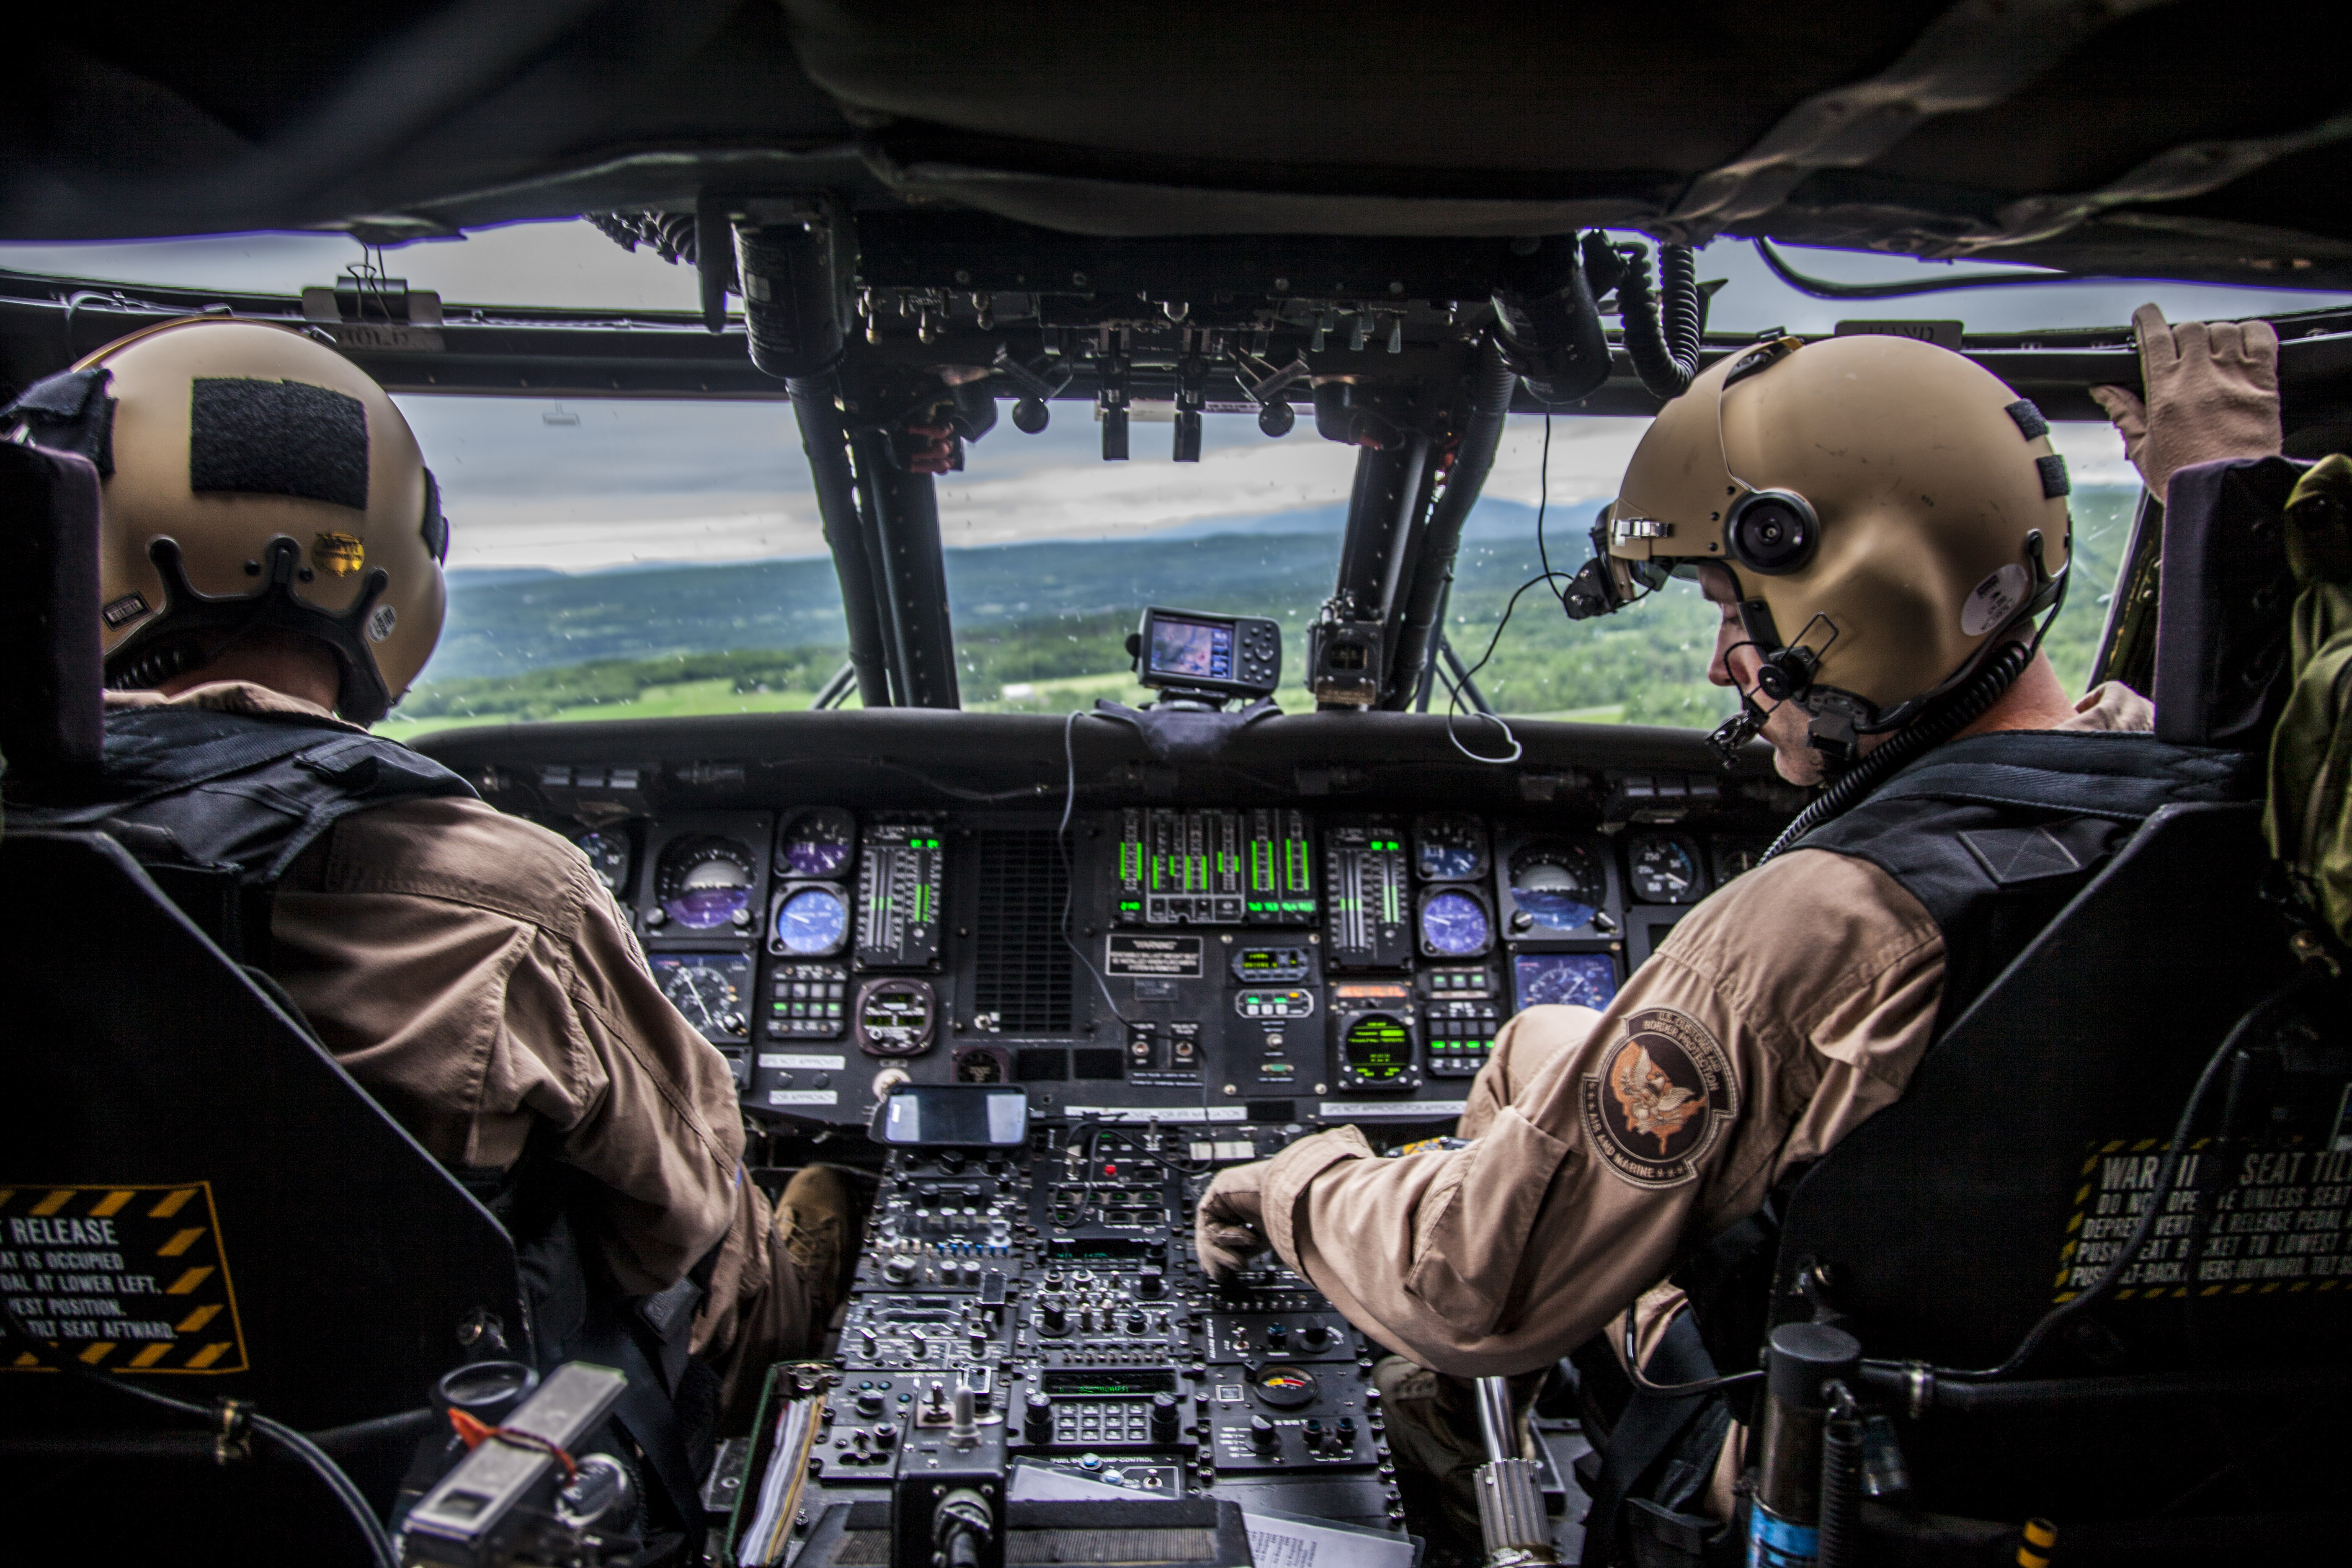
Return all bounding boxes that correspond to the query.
[0,0,2352,287]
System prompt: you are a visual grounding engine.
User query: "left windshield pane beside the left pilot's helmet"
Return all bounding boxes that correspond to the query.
[377,397,844,738]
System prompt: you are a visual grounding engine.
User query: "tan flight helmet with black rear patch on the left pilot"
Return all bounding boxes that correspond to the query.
[5,317,449,724]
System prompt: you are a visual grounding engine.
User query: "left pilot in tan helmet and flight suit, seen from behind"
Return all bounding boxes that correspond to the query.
[0,317,849,1415]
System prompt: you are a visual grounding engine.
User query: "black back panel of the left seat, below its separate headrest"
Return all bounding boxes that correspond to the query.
[0,832,527,1429]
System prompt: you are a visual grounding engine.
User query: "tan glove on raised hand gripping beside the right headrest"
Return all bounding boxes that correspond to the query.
[2091,306,2279,501]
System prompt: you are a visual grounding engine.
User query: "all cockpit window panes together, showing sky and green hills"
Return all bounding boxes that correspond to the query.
[13,221,2343,736]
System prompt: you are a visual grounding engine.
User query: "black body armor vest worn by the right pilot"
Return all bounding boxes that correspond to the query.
[1571,731,2263,1568]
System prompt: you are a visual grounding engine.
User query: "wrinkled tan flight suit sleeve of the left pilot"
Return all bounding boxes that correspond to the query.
[271,799,743,1293]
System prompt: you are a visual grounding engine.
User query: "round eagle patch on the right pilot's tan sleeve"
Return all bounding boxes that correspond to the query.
[1581,1006,1741,1187]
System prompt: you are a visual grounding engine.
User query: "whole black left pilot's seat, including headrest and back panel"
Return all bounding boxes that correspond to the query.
[0,425,531,1561]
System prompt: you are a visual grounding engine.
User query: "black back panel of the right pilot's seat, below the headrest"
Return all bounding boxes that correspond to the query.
[1773,804,2352,1519]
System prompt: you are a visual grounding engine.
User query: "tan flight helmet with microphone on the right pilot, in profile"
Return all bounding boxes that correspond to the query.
[1569,336,2072,759]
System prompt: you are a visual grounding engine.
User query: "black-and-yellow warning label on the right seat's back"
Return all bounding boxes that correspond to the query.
[2055,1138,2352,1300]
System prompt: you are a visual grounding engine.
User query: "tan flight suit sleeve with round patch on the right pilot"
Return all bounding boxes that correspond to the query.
[1261,851,1943,1375]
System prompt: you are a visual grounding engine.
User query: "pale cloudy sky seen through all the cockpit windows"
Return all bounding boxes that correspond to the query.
[0,223,2343,571]
